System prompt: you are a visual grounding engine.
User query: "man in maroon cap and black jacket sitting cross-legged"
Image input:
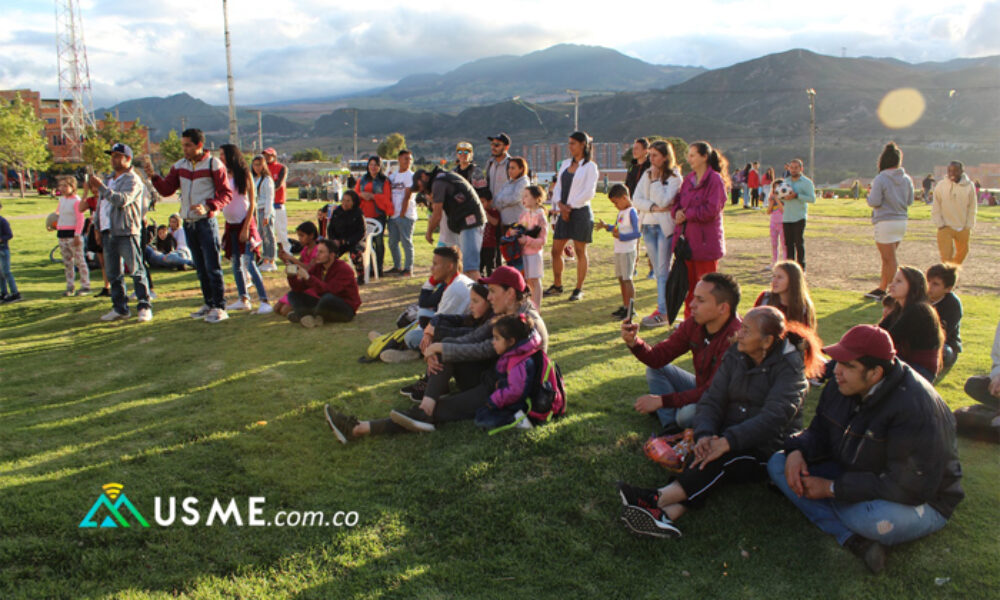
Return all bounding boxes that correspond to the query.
[767,325,965,573]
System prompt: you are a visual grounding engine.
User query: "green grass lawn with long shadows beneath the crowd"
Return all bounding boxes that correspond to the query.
[0,189,1000,600]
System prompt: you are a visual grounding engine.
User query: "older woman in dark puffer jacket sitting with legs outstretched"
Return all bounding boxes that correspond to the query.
[618,306,823,538]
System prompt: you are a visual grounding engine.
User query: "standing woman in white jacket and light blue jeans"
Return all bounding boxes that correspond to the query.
[633,140,682,327]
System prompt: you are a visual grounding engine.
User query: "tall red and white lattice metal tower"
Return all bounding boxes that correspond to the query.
[55,0,96,162]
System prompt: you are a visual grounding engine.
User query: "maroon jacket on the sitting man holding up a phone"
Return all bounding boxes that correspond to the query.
[630,316,743,408]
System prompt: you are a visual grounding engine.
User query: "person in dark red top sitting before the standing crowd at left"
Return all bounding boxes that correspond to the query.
[278,240,361,328]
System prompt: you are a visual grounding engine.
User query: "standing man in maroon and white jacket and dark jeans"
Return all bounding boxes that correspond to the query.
[144,129,233,323]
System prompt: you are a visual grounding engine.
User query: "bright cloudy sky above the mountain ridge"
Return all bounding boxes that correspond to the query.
[0,0,1000,108]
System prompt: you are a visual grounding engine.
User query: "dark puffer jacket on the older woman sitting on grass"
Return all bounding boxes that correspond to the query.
[694,340,809,460]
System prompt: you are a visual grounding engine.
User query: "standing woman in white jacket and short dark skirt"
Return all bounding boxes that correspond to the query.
[543,131,600,302]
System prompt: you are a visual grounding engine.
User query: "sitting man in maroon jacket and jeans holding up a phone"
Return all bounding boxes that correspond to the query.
[622,273,741,430]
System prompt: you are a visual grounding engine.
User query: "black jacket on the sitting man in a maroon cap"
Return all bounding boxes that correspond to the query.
[785,359,965,518]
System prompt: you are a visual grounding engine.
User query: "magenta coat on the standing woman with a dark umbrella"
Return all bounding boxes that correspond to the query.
[671,169,726,261]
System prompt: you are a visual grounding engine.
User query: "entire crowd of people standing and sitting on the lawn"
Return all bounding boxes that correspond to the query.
[0,129,1000,572]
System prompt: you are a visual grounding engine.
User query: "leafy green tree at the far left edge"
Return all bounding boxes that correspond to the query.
[0,94,51,198]
